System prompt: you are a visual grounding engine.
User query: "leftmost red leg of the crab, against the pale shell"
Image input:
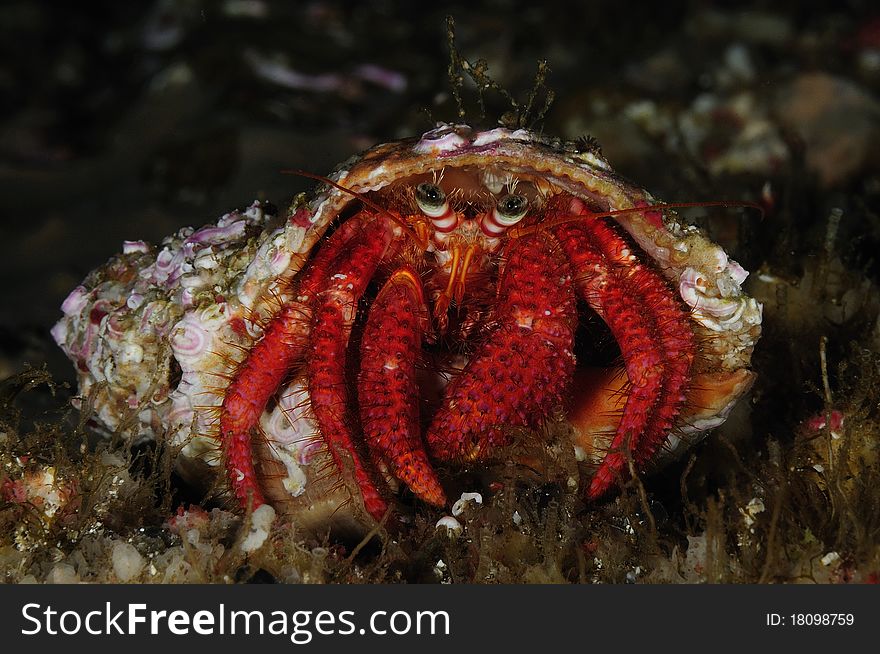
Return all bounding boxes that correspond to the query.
[220,216,384,508]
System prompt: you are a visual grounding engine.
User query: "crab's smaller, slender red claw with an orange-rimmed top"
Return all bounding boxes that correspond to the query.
[358,268,446,506]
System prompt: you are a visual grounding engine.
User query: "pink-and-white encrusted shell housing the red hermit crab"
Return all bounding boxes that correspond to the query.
[52,124,761,524]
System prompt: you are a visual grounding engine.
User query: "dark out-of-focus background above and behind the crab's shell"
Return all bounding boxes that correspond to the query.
[0,0,880,378]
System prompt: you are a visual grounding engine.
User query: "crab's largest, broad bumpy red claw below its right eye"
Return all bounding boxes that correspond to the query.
[427,235,577,460]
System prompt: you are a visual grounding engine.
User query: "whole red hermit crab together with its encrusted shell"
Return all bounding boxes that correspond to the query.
[53,124,761,524]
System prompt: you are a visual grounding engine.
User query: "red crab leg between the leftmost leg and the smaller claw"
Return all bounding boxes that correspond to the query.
[307,218,392,520]
